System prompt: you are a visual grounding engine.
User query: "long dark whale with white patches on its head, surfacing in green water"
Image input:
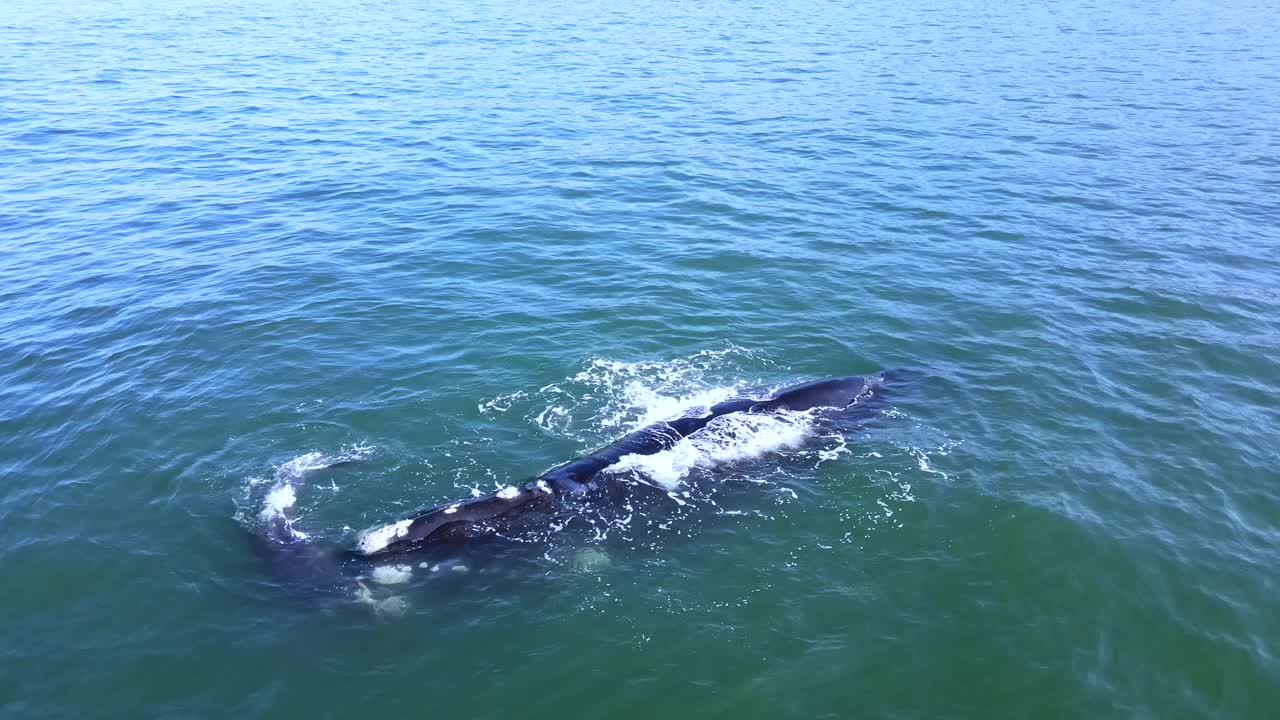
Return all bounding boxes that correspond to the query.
[255,370,910,579]
